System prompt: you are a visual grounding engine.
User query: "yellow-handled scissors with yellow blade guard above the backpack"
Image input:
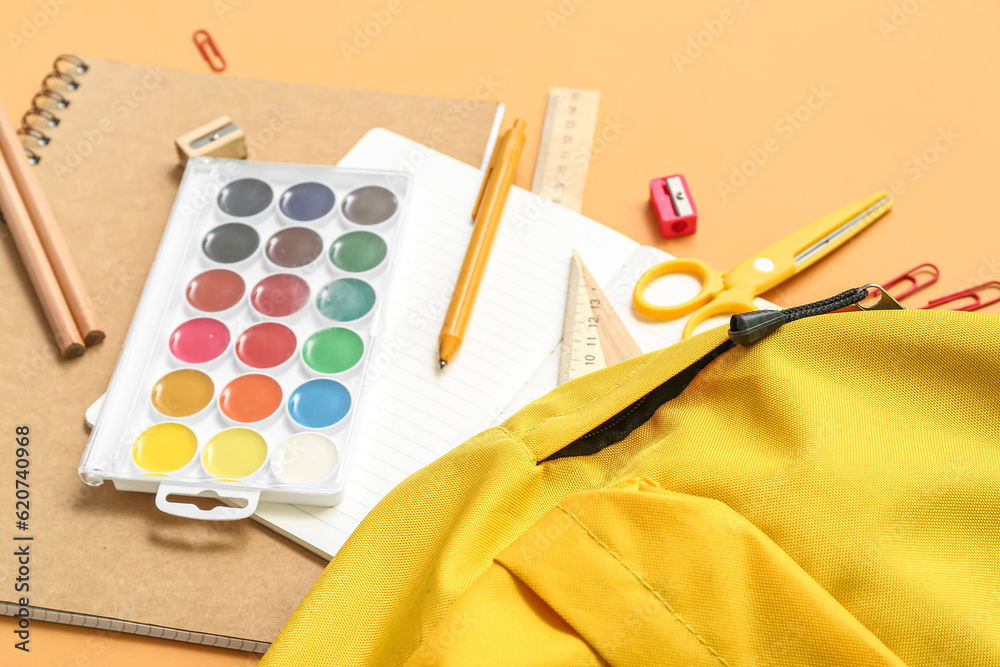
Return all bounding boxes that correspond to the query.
[632,191,892,338]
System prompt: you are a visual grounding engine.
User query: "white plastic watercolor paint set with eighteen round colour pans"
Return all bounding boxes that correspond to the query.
[80,158,409,519]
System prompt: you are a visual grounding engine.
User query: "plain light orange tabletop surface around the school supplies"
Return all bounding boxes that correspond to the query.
[0,0,1000,665]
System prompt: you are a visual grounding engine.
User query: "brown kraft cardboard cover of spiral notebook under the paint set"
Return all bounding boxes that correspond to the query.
[0,58,498,650]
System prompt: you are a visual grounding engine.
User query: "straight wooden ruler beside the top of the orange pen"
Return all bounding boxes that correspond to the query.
[531,88,601,213]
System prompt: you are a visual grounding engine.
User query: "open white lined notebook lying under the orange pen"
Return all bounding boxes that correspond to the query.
[255,130,639,558]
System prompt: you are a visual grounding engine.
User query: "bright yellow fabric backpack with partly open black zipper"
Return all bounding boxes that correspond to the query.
[261,311,1000,667]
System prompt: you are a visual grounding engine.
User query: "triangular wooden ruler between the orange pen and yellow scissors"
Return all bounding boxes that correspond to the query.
[559,250,642,384]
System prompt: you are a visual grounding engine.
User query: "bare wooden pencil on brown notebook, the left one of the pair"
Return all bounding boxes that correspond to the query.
[0,136,85,358]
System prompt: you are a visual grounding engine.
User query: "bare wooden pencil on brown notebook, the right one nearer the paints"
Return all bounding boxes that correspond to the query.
[0,103,104,346]
